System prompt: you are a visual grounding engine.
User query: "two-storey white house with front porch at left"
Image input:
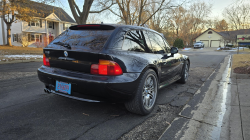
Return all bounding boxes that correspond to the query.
[0,1,76,47]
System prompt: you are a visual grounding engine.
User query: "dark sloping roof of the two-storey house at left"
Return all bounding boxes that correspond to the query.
[22,1,75,23]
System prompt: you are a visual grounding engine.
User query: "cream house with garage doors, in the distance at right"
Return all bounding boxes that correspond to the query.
[194,28,250,47]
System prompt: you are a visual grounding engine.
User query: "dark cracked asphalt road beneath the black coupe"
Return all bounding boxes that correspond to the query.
[0,49,234,140]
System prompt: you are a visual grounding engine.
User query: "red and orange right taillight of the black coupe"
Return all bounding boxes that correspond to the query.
[90,60,123,75]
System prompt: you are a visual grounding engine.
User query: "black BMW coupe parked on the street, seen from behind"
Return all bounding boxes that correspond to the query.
[37,24,190,115]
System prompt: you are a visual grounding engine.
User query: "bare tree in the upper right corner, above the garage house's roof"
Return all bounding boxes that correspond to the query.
[223,4,250,30]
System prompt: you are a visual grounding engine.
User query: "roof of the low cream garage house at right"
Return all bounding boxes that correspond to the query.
[194,28,250,39]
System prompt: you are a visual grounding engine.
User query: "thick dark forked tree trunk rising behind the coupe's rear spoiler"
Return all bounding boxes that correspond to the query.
[68,0,115,24]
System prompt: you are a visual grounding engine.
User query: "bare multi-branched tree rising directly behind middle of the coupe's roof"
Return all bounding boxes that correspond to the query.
[109,0,180,26]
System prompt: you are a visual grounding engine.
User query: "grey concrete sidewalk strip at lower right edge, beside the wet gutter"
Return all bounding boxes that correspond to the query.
[229,73,250,140]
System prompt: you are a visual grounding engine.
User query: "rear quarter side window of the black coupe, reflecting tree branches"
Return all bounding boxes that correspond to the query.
[122,30,152,53]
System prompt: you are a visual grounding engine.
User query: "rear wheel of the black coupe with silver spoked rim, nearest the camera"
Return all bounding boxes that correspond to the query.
[125,69,158,115]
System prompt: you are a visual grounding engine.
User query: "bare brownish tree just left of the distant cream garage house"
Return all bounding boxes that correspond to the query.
[168,2,212,45]
